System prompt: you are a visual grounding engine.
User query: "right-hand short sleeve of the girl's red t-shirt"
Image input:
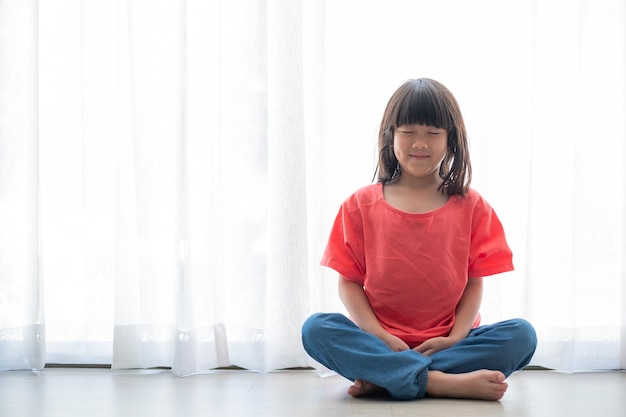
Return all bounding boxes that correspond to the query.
[468,198,513,278]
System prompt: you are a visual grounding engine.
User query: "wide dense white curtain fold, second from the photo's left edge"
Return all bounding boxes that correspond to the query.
[113,1,185,368]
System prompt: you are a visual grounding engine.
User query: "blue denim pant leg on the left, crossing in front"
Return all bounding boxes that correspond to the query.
[302,313,430,399]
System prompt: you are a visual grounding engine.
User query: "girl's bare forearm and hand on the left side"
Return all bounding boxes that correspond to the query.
[339,275,409,352]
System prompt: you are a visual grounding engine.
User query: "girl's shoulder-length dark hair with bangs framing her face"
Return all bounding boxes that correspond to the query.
[374,78,472,196]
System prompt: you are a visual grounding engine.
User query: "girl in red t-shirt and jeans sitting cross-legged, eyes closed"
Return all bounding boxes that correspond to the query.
[302,79,537,400]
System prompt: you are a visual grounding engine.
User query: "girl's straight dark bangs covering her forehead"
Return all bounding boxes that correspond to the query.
[395,80,454,130]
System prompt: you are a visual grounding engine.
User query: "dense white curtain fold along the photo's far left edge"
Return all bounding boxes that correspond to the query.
[0,1,46,370]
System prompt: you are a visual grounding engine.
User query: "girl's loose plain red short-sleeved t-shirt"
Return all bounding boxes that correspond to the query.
[321,184,513,347]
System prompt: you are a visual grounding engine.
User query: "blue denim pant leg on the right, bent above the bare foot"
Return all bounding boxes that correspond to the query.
[429,319,537,377]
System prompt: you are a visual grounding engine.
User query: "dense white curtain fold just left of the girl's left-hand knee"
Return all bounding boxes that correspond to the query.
[265,0,311,369]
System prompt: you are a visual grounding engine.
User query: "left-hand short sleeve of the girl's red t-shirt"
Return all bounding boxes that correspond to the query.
[321,202,365,285]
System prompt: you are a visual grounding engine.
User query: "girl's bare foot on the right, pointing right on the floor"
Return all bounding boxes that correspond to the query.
[426,369,509,401]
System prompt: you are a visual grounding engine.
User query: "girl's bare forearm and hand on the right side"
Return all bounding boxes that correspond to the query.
[414,278,483,355]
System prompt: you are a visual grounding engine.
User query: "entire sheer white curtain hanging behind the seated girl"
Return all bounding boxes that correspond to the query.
[0,0,626,375]
